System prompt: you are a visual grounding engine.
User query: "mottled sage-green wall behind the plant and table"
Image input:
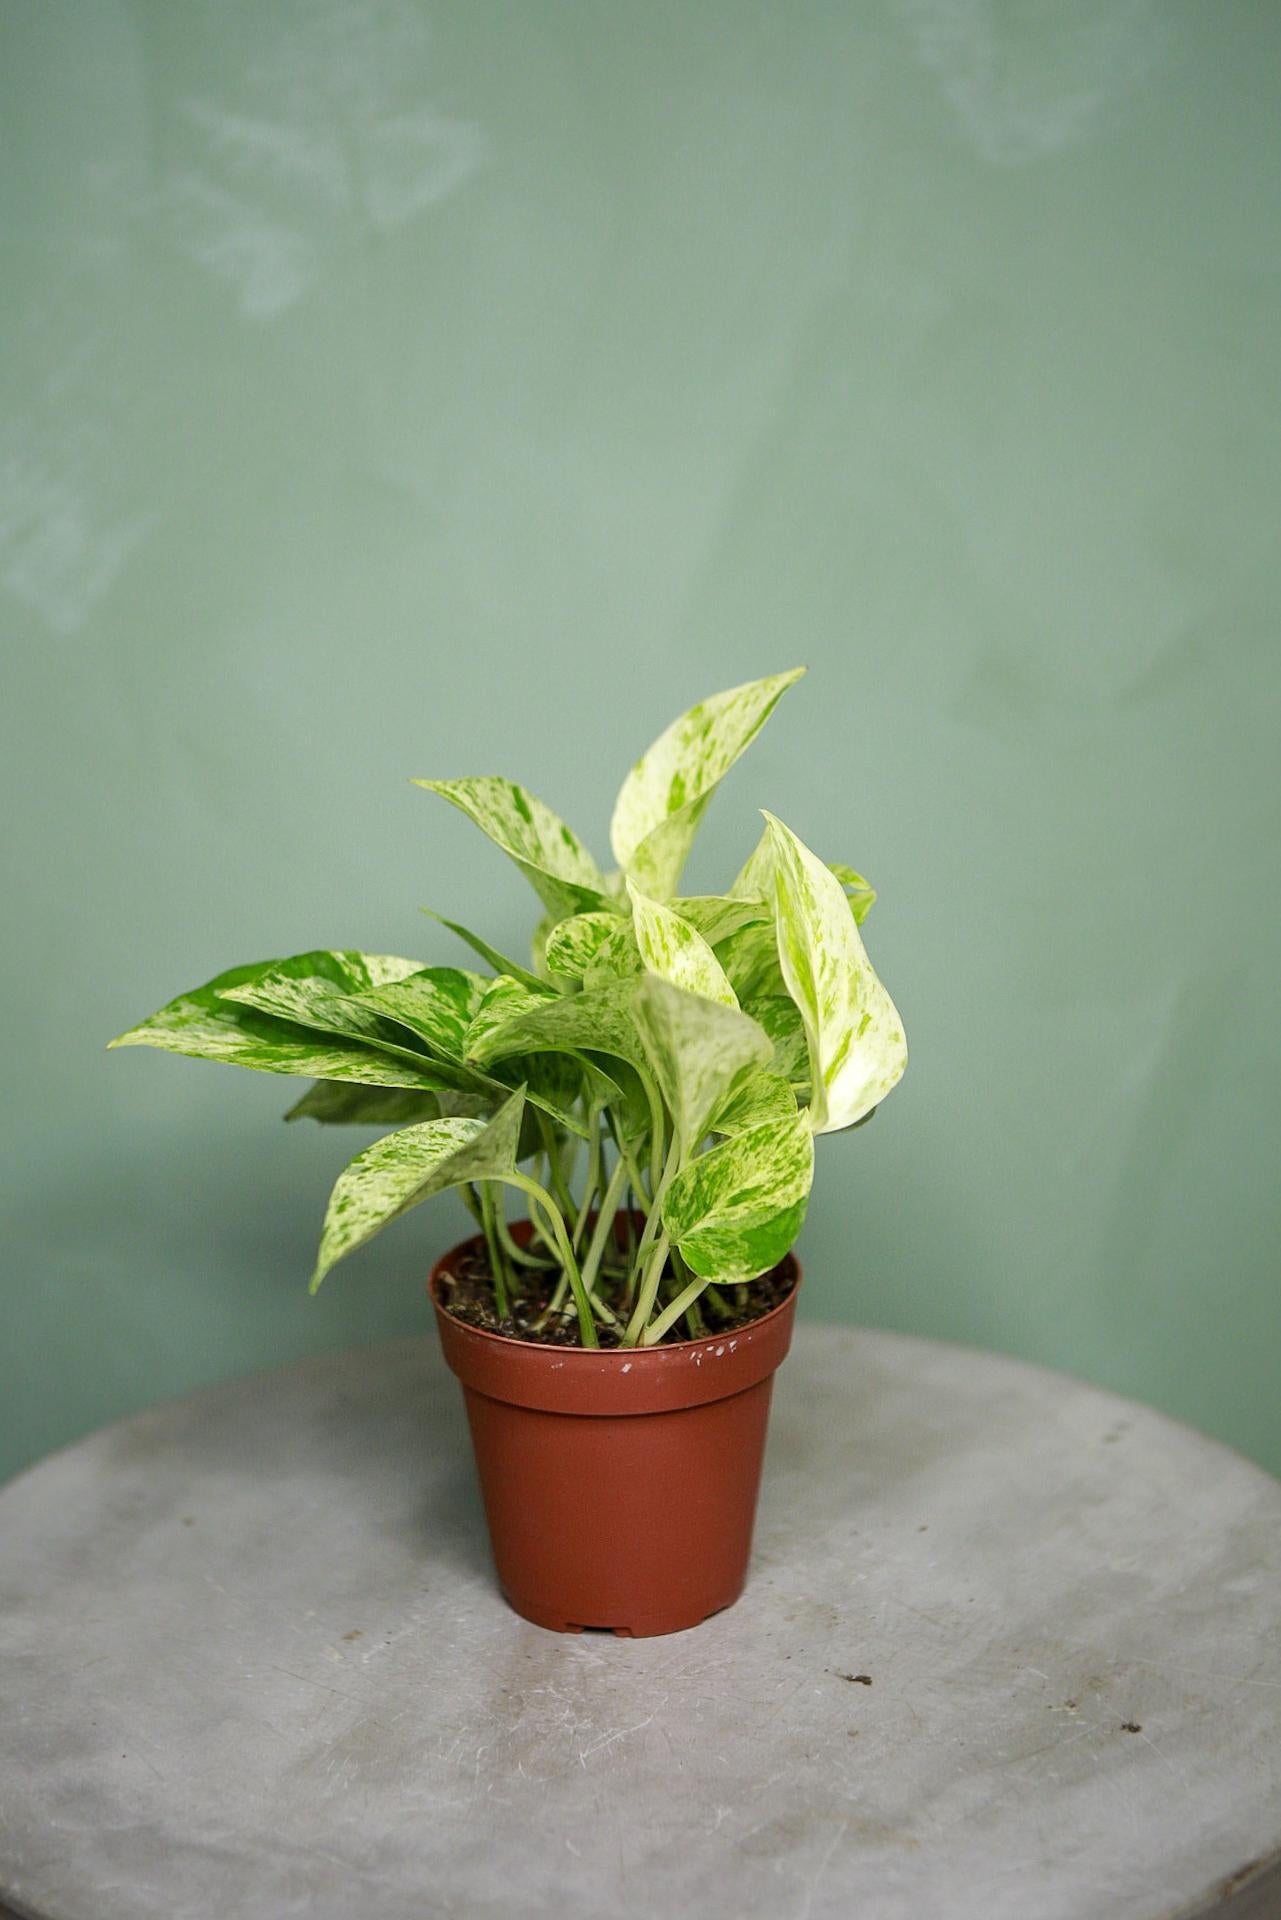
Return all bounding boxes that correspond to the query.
[0,0,1281,1467]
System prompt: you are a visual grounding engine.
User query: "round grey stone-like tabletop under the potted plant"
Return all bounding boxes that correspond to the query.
[0,1327,1281,1920]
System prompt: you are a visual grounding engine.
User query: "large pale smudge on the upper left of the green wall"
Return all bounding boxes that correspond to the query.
[159,0,486,321]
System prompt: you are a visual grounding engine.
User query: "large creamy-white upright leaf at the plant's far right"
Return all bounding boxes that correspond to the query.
[764,814,906,1133]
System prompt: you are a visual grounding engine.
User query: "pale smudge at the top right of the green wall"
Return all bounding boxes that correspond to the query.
[899,0,1168,165]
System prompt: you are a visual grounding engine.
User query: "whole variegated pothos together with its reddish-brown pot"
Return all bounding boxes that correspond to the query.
[111,668,906,1634]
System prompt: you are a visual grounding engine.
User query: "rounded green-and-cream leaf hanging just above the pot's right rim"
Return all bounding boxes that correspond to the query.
[663,1114,814,1283]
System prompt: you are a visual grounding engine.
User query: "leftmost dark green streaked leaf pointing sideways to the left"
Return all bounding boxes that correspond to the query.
[111,960,460,1091]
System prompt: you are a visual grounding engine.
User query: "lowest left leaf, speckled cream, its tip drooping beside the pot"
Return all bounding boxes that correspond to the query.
[311,1091,524,1292]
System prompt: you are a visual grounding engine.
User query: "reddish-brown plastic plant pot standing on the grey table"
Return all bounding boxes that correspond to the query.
[430,1223,801,1638]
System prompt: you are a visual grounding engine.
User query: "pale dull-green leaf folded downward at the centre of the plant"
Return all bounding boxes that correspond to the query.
[633,973,770,1154]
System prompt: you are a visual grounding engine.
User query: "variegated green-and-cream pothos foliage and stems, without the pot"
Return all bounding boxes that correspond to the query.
[111,668,906,1346]
